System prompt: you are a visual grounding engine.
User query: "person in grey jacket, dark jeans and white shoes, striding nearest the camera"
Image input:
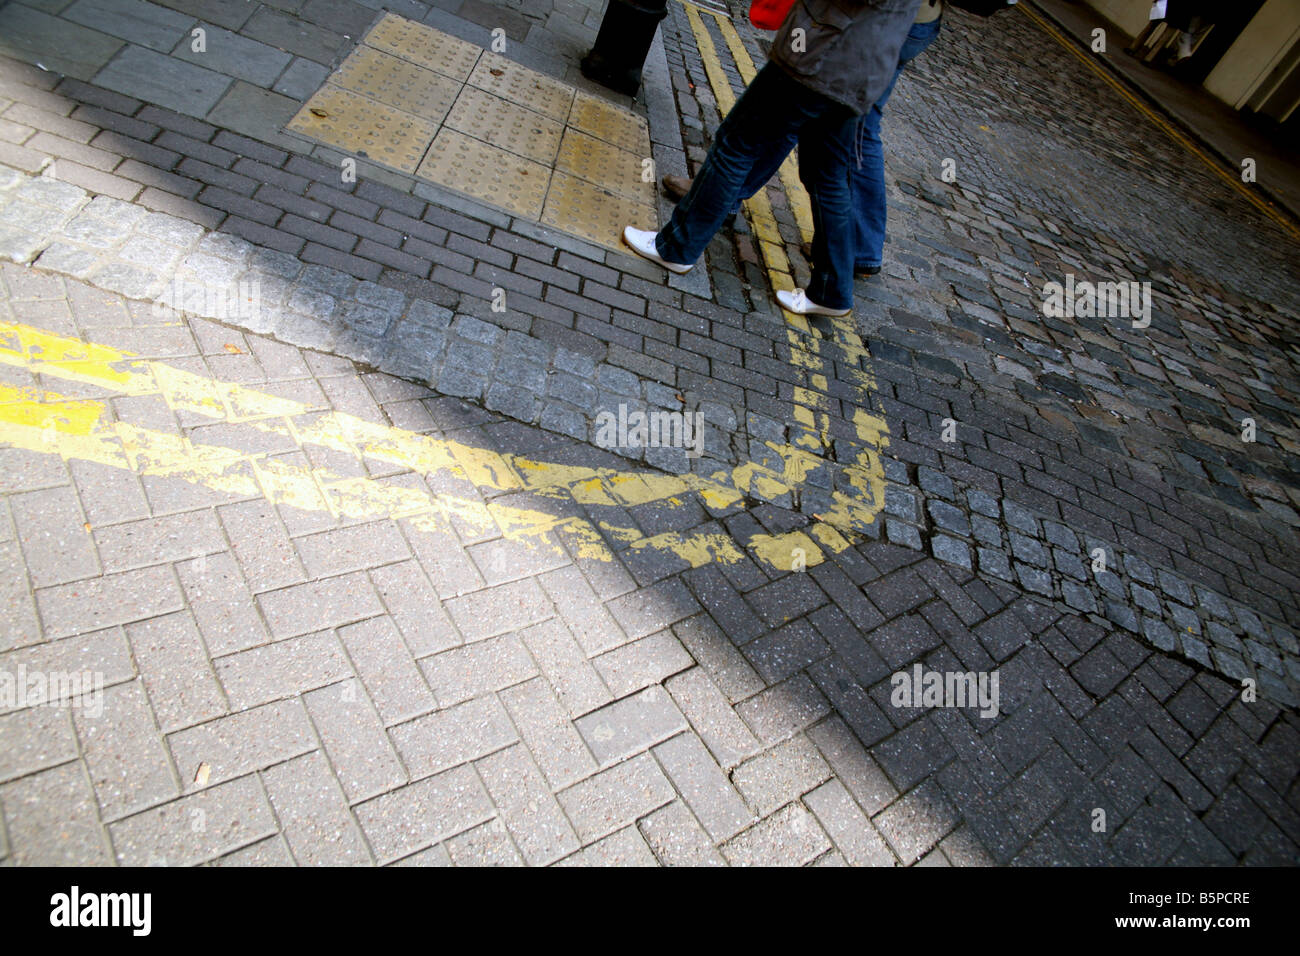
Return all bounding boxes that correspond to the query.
[623,0,923,316]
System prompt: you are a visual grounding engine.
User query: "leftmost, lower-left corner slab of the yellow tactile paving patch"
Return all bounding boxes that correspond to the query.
[289,85,438,173]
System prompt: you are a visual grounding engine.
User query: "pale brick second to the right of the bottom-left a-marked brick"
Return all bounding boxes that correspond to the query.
[356,766,493,862]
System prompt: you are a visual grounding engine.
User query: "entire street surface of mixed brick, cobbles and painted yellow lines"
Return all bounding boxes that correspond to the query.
[0,0,1300,866]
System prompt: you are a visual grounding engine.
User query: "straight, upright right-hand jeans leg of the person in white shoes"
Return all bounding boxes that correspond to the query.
[800,108,859,308]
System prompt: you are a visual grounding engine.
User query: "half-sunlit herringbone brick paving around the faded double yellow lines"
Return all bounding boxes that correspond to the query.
[0,265,1300,864]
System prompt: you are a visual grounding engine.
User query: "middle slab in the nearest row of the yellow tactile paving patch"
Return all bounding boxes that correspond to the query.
[416,126,551,221]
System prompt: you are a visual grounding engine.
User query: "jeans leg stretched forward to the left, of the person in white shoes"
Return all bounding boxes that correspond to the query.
[655,64,832,264]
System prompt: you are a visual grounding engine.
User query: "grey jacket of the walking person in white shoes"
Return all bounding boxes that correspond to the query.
[771,0,922,114]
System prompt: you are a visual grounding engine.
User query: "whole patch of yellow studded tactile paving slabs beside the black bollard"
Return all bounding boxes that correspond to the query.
[286,13,658,252]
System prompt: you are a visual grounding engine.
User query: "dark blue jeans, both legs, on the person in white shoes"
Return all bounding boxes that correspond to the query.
[655,62,858,308]
